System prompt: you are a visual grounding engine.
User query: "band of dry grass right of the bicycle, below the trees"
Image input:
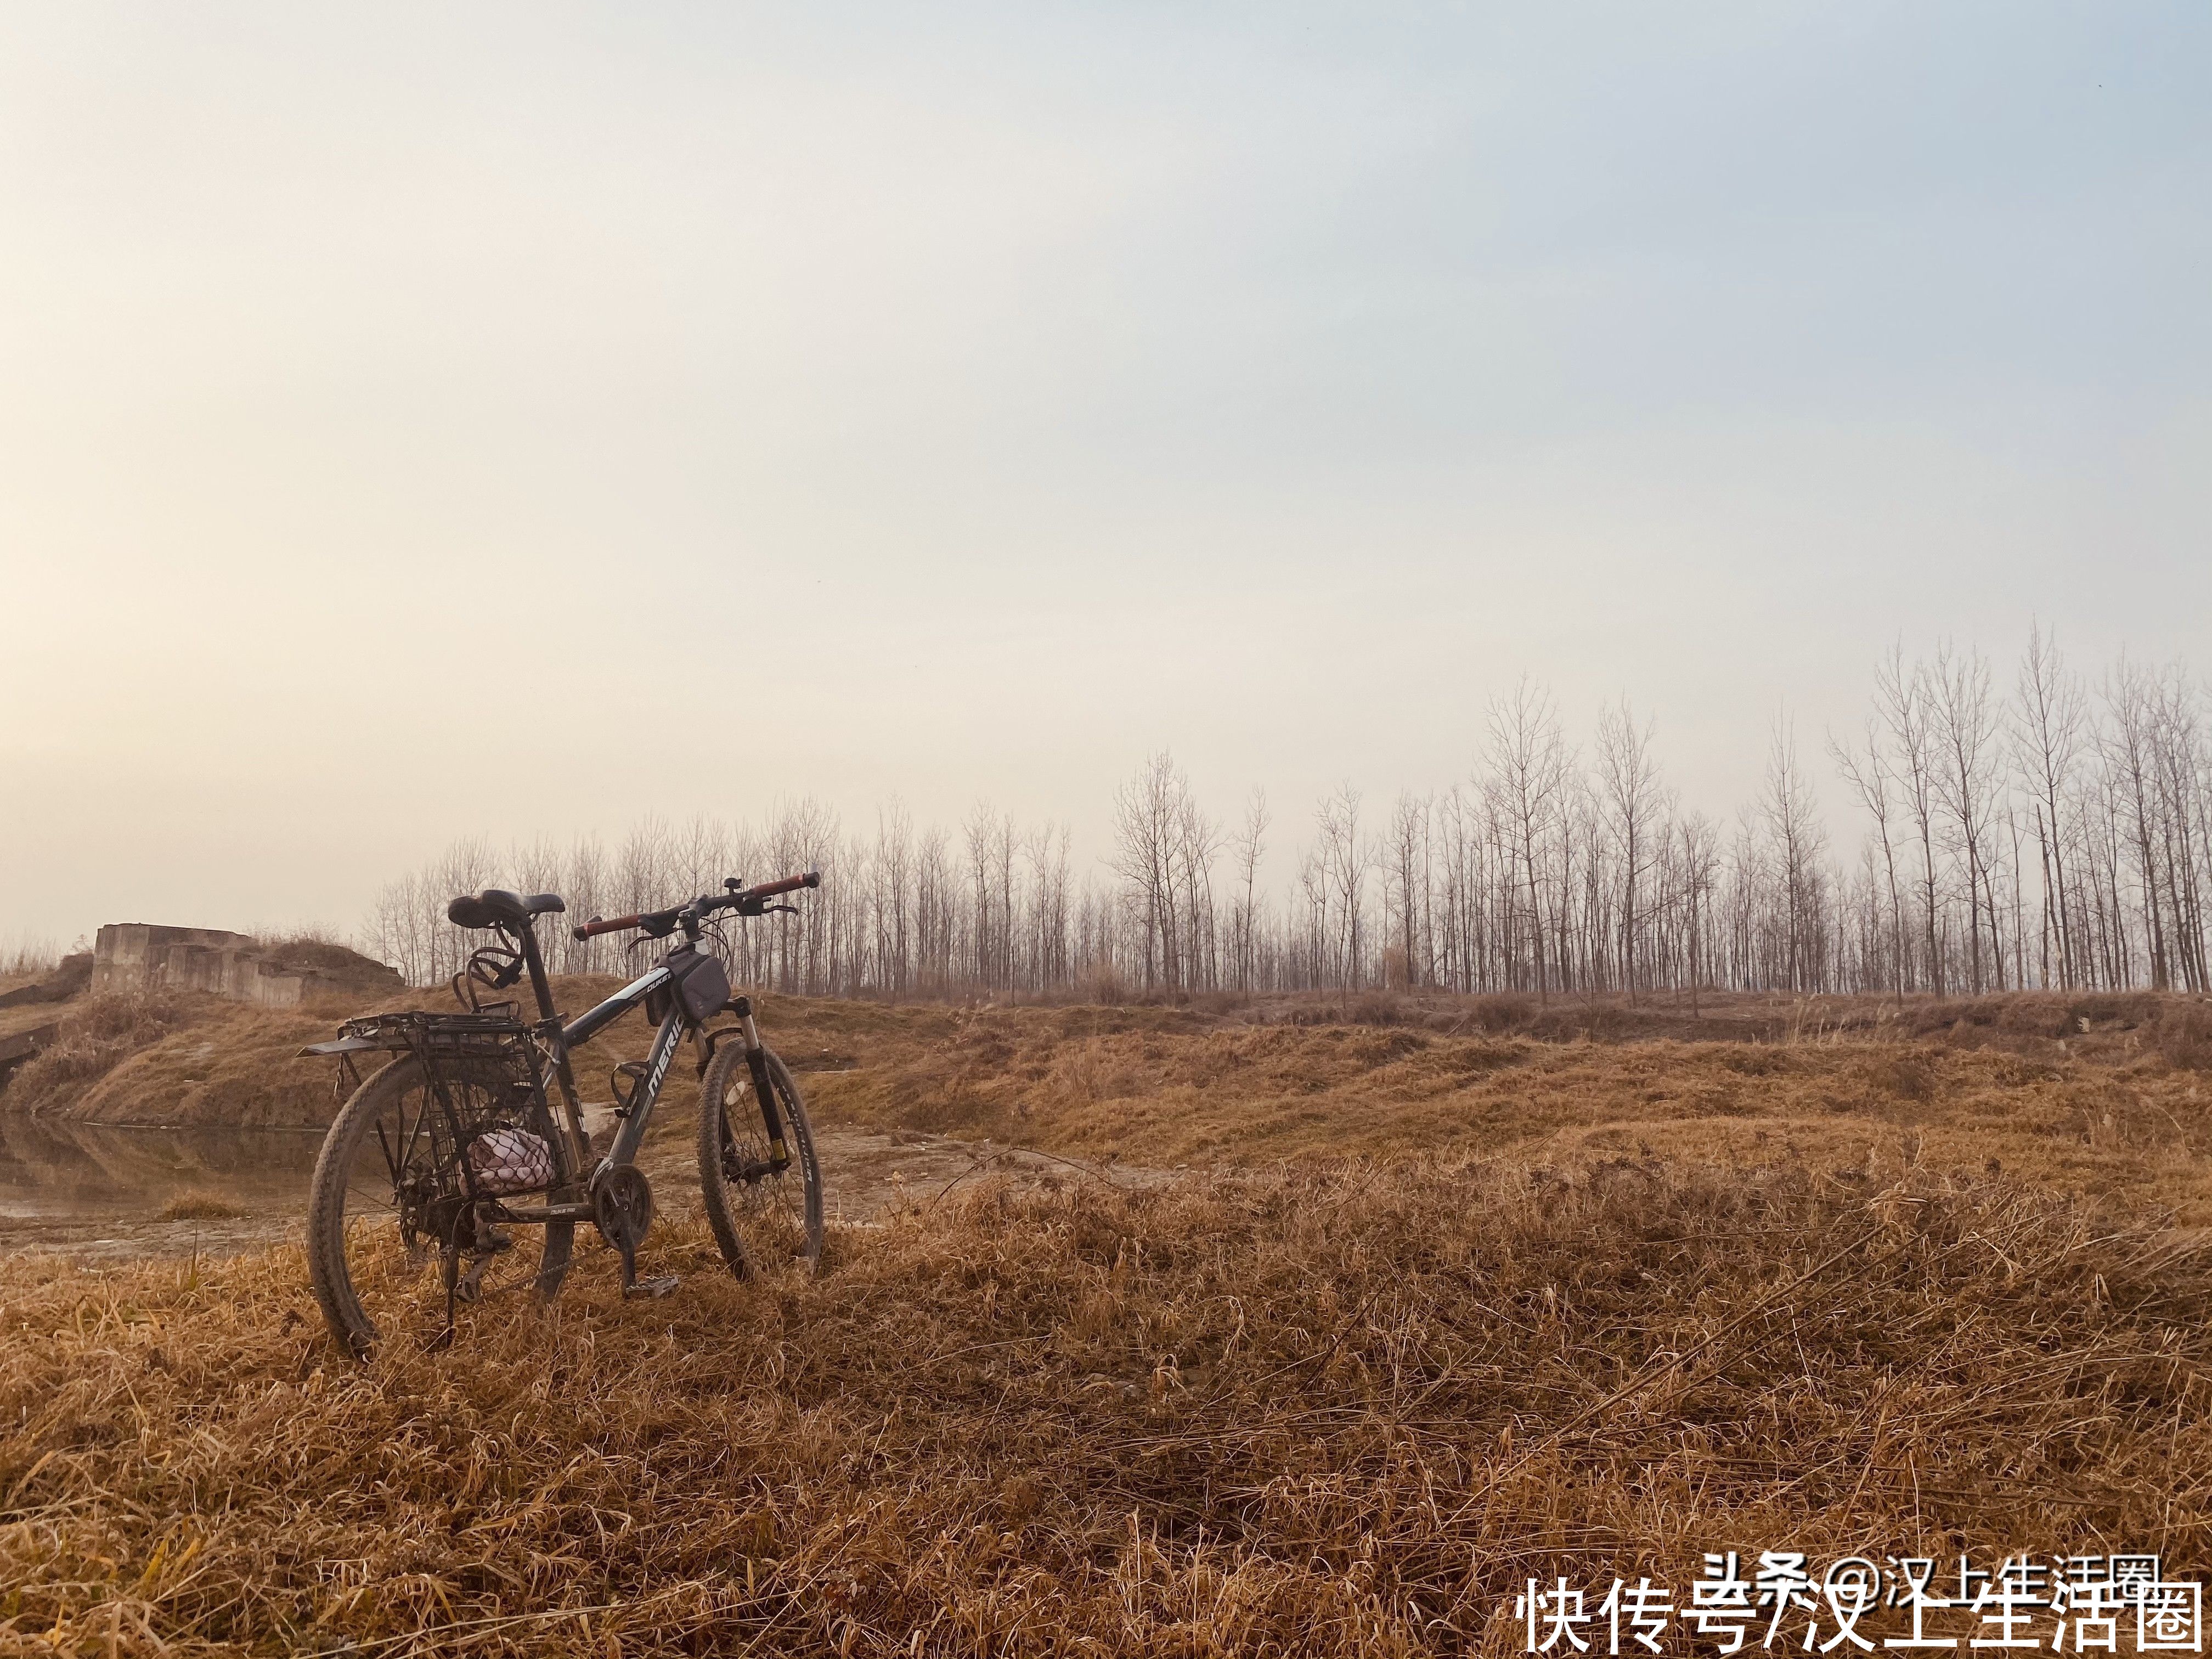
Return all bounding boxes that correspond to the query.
[783,997,2212,1226]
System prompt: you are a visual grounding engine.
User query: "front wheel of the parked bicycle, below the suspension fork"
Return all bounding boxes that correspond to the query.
[699,1042,823,1278]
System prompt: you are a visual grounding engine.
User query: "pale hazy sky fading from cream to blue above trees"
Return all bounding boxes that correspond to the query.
[0,0,2212,943]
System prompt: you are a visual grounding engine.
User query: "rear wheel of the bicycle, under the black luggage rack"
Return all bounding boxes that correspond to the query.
[307,1055,575,1358]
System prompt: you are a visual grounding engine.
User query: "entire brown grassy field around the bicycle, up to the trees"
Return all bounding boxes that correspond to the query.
[0,984,2212,1655]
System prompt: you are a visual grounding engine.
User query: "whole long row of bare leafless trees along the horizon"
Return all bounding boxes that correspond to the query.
[365,630,2212,997]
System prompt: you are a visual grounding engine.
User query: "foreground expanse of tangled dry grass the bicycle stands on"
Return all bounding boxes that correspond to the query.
[0,1164,2212,1655]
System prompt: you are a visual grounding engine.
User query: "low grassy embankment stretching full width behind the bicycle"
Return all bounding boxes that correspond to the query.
[0,978,2212,1226]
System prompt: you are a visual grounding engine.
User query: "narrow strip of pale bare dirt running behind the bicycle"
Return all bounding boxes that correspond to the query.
[0,1128,1175,1263]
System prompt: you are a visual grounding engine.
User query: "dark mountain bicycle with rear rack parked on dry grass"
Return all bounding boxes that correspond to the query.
[301,872,823,1361]
